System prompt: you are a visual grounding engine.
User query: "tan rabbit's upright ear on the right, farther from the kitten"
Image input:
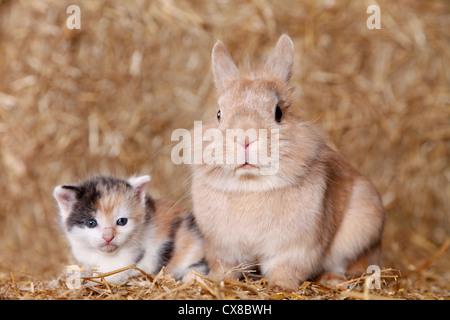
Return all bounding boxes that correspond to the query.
[266,34,294,82]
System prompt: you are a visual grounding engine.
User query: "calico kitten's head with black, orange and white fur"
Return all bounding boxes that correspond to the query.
[54,176,149,253]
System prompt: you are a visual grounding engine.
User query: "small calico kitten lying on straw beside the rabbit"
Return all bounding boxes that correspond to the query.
[53,176,208,283]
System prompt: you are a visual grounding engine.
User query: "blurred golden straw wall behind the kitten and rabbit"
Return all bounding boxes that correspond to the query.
[0,0,450,296]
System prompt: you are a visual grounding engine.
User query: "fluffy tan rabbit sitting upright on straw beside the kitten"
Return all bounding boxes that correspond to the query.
[191,35,384,290]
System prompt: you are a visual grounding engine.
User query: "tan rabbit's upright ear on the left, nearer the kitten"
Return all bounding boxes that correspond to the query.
[211,40,239,91]
